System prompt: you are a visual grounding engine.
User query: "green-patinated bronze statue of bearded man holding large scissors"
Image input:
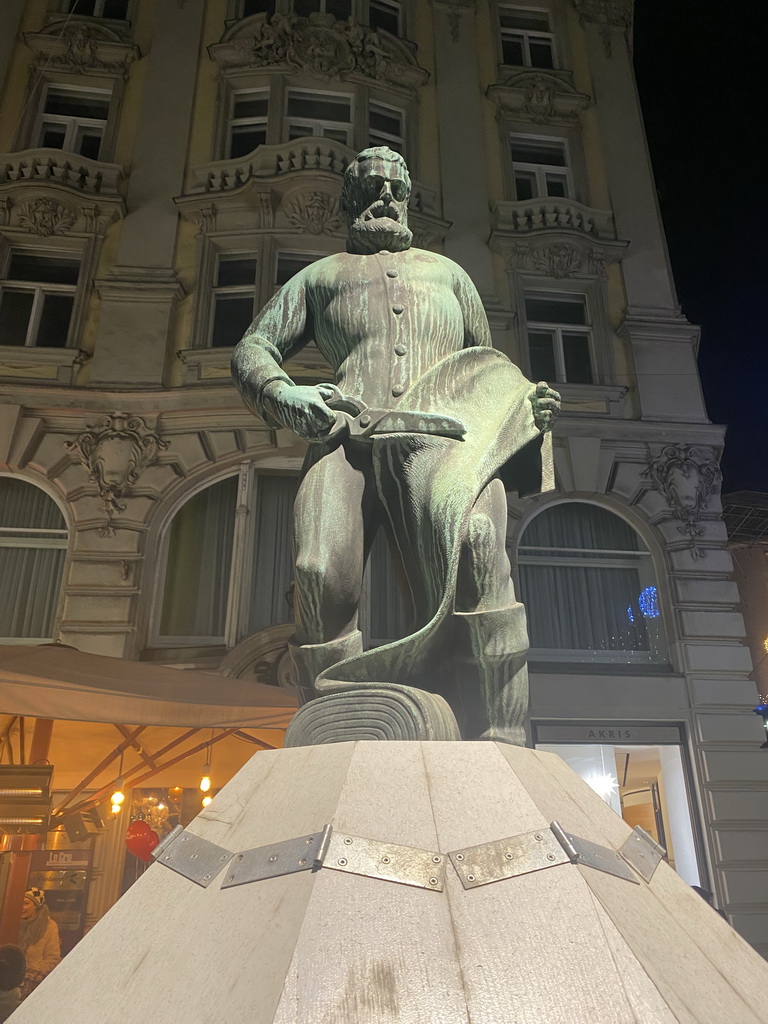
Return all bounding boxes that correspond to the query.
[232,147,559,743]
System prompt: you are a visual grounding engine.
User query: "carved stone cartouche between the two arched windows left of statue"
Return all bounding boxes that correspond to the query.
[65,413,169,537]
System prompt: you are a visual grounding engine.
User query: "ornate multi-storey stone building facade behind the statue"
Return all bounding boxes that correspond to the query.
[0,0,768,953]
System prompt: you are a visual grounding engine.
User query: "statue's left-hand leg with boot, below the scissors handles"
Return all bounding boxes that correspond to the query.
[289,445,370,700]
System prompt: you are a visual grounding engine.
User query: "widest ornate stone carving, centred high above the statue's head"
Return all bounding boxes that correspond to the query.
[211,12,427,88]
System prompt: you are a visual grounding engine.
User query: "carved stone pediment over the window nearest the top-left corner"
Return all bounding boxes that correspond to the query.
[25,20,139,78]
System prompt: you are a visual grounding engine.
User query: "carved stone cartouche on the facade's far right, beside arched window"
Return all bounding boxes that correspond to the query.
[645,444,722,558]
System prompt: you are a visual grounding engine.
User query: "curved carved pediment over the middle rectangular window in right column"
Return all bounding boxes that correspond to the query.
[487,69,592,124]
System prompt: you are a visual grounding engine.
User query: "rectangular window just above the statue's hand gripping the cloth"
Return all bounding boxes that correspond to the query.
[525,292,593,384]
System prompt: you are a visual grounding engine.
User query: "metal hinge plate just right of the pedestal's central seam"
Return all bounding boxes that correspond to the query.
[449,828,570,889]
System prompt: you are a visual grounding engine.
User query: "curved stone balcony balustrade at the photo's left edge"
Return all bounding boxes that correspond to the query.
[0,150,123,196]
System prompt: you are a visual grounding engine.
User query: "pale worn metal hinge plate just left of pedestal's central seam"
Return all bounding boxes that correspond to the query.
[323,831,445,893]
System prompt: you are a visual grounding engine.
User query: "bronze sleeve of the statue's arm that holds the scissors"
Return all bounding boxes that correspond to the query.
[232,268,312,416]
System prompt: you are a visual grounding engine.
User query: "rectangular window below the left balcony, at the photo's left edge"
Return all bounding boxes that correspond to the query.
[0,252,80,348]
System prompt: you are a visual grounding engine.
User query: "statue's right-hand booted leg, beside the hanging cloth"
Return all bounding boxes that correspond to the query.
[454,479,528,745]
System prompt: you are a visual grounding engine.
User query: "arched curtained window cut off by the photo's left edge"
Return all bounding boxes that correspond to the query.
[0,477,67,642]
